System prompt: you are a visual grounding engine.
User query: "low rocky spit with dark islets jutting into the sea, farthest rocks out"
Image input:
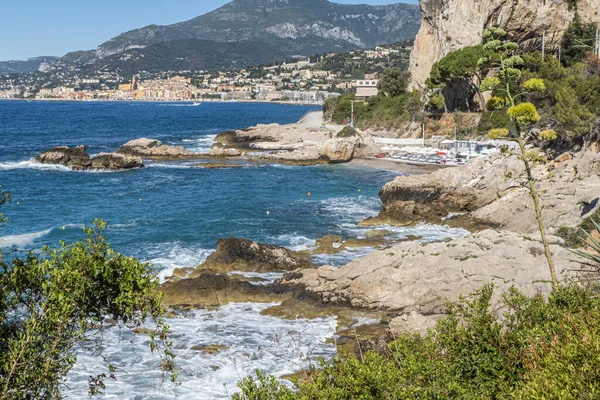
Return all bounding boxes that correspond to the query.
[34,112,442,174]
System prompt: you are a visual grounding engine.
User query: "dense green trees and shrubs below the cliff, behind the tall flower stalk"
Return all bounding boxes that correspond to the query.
[427,21,600,142]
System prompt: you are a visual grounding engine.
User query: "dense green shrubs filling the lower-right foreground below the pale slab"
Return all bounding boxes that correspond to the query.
[235,284,600,400]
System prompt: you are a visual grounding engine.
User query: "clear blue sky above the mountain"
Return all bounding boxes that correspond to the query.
[0,0,417,60]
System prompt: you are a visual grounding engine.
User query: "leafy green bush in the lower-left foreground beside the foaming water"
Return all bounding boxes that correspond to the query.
[0,194,177,400]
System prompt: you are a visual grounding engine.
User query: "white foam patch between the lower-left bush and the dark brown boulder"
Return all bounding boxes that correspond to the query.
[146,242,214,283]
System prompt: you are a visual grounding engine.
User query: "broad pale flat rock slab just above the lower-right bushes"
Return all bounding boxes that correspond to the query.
[282,230,579,315]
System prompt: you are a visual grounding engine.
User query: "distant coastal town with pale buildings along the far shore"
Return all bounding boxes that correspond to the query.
[0,42,412,104]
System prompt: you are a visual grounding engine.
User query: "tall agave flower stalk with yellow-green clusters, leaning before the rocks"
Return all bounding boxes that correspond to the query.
[478,28,558,290]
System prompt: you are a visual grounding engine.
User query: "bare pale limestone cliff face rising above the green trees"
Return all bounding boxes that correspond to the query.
[410,0,600,88]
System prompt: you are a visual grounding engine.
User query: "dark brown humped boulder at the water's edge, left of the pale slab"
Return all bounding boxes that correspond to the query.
[198,238,313,273]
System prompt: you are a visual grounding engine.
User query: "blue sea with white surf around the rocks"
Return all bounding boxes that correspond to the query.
[0,101,465,399]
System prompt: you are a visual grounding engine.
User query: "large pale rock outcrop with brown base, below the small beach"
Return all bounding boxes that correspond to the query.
[361,151,600,234]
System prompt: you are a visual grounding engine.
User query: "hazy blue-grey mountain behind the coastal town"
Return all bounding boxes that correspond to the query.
[3,0,420,73]
